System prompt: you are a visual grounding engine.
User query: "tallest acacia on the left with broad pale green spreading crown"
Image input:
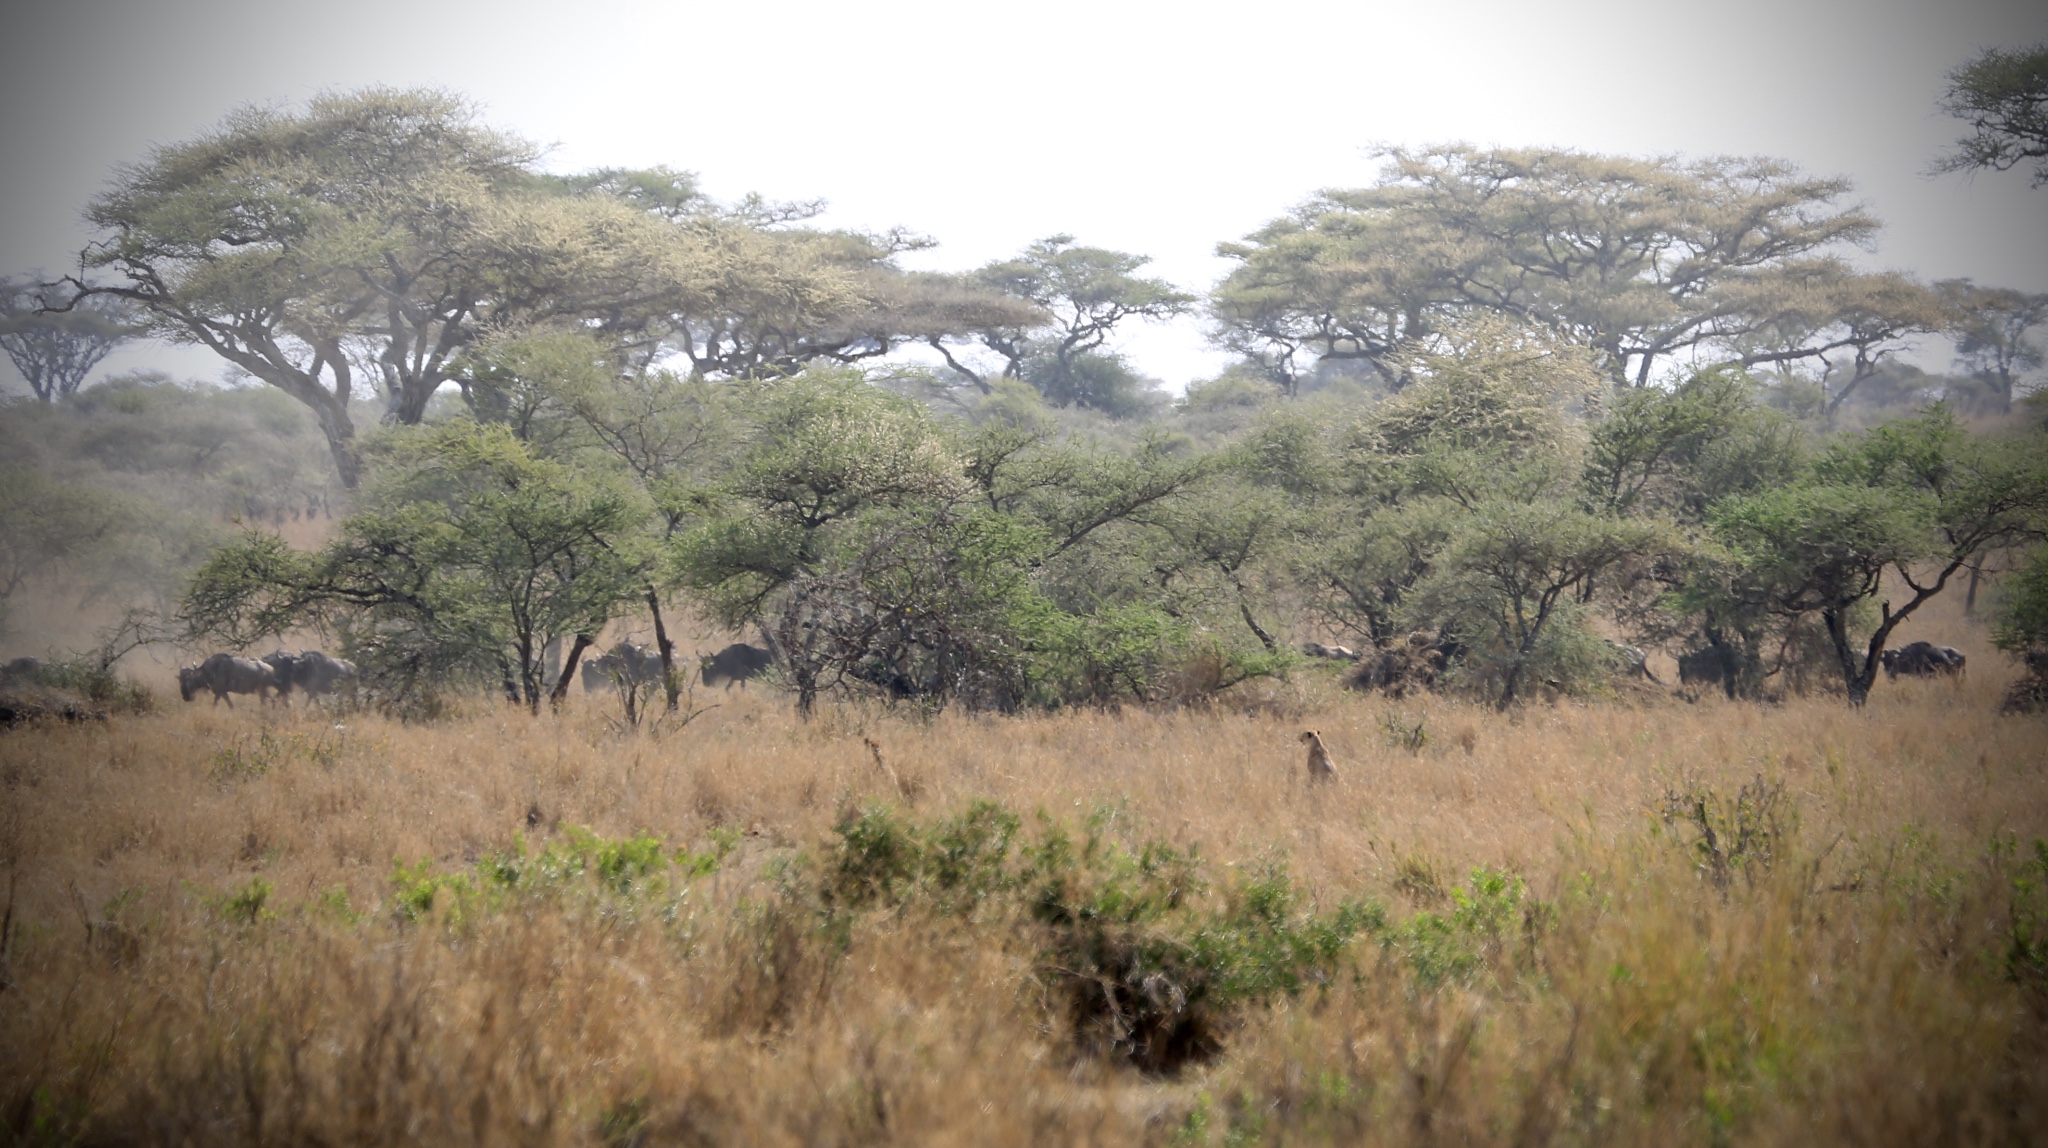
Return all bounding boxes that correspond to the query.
[70,88,705,487]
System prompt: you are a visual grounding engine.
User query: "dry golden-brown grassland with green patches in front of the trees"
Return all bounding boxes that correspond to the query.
[0,585,2048,1144]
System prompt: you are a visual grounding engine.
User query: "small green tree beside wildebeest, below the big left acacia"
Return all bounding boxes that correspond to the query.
[180,424,647,712]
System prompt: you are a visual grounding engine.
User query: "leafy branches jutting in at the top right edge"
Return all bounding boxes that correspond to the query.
[1933,43,2048,186]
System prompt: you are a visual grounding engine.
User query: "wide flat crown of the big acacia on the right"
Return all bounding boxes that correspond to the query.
[1210,145,1878,391]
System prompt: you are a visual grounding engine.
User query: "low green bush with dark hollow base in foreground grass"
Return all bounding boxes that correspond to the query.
[815,802,1384,1072]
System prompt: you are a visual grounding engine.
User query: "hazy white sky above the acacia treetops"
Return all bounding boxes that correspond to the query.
[0,0,2048,387]
